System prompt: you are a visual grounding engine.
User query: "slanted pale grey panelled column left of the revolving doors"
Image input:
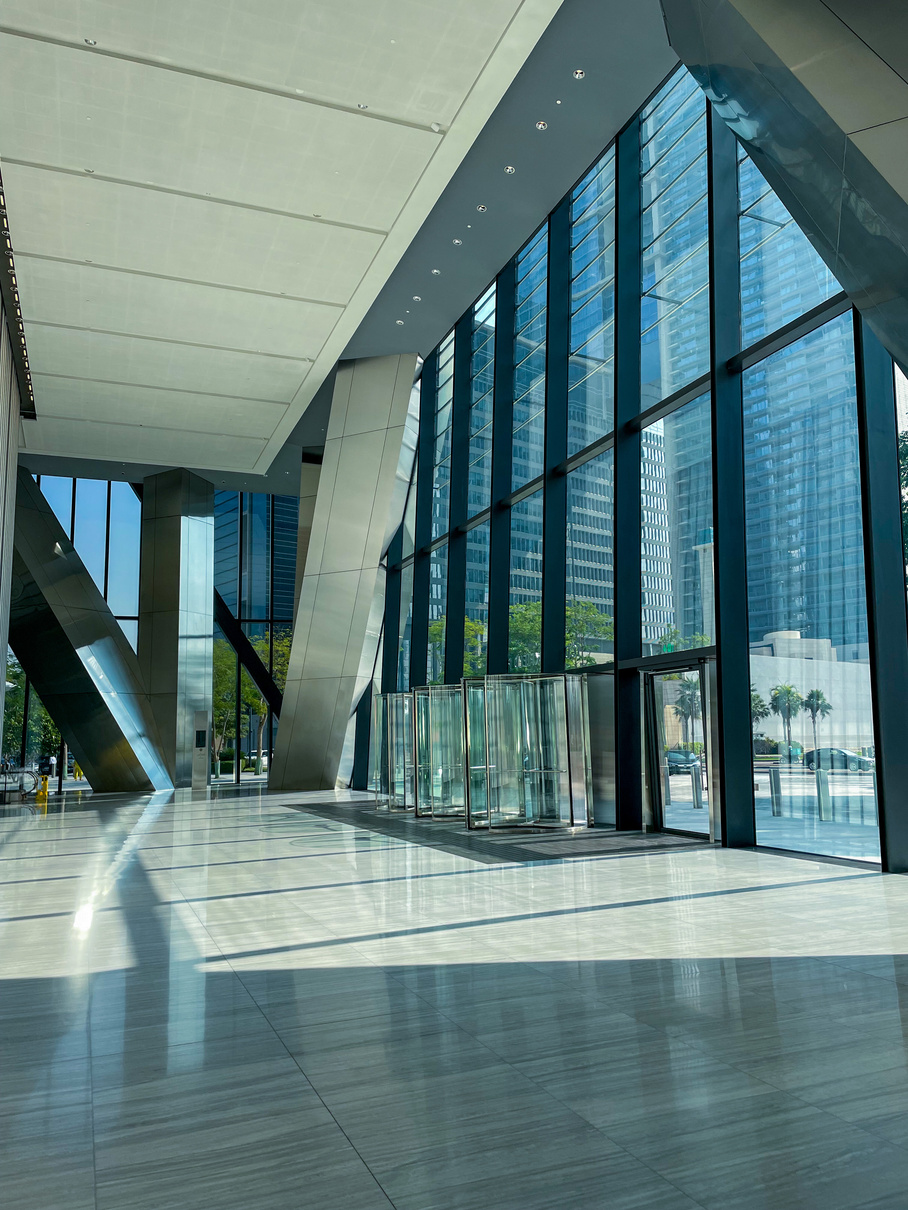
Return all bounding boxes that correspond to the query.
[269,355,416,790]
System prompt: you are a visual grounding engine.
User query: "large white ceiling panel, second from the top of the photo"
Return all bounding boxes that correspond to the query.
[0,35,441,231]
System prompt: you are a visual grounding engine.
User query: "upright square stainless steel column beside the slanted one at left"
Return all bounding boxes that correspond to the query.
[139,469,214,787]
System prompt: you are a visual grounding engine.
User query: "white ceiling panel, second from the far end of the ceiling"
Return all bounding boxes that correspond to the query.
[34,374,286,437]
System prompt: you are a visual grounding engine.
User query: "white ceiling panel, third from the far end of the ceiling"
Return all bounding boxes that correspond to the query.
[22,324,308,404]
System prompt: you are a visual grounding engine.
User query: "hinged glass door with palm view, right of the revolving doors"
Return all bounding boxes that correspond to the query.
[645,662,717,837]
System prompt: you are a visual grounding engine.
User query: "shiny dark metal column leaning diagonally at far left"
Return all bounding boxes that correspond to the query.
[10,469,172,793]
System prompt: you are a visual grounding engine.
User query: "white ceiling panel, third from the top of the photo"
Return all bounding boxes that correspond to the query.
[2,165,381,303]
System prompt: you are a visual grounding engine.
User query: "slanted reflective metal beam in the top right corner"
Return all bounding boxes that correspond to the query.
[662,0,908,365]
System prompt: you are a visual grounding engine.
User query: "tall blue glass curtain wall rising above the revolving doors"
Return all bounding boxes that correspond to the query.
[383,68,908,859]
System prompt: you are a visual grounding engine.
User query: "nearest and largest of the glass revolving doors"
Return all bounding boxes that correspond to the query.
[464,674,592,829]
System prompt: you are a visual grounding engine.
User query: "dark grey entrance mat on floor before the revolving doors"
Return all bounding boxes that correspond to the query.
[287,802,711,865]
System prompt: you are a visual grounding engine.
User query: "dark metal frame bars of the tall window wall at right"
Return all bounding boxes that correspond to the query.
[383,69,908,871]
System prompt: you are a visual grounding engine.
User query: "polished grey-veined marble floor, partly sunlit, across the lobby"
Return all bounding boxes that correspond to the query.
[0,788,908,1210]
